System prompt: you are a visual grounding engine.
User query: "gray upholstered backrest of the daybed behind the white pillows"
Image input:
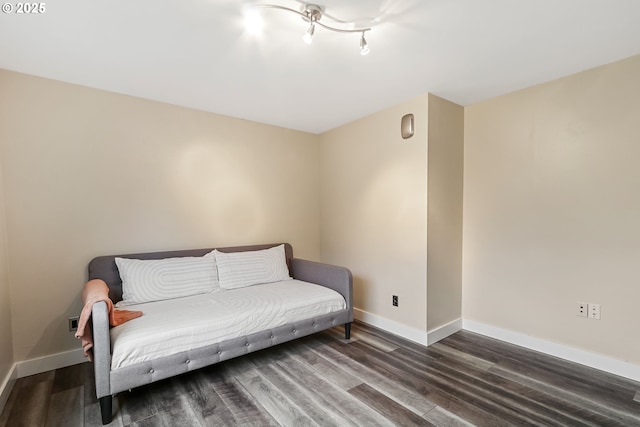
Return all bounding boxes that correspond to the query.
[89,243,293,304]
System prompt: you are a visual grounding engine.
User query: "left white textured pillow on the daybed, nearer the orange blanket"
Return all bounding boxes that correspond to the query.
[116,251,220,307]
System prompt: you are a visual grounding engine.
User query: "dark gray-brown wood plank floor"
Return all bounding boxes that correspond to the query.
[0,323,640,427]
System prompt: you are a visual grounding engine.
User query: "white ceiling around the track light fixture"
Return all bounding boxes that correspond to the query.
[0,0,640,133]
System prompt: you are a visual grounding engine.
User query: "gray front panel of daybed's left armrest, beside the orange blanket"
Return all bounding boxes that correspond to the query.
[91,301,111,398]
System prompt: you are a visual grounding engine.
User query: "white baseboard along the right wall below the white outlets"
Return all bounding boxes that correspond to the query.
[462,319,640,381]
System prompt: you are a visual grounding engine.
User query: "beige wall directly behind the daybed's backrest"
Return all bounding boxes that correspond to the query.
[0,71,320,361]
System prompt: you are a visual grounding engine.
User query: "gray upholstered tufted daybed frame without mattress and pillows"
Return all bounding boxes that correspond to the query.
[89,244,353,424]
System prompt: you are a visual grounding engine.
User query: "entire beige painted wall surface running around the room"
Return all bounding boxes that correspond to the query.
[6,50,640,372]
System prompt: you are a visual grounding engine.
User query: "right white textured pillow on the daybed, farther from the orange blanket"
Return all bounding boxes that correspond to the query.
[214,245,291,289]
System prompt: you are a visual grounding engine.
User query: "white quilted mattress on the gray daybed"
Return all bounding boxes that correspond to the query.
[111,280,346,369]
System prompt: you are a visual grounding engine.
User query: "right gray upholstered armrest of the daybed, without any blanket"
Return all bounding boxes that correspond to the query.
[291,258,353,321]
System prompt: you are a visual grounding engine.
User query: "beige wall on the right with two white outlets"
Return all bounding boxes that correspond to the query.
[463,56,640,364]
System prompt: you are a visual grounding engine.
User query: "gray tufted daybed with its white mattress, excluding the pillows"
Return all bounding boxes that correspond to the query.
[89,244,353,424]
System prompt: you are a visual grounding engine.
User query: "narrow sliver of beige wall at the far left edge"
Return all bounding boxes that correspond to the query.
[0,156,13,384]
